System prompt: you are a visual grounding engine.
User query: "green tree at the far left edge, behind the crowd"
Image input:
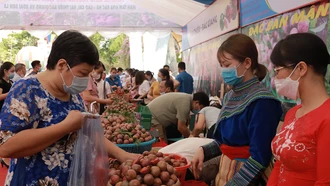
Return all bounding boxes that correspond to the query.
[0,31,39,62]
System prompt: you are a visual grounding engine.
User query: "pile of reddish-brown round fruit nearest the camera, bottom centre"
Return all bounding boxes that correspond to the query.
[108,152,187,186]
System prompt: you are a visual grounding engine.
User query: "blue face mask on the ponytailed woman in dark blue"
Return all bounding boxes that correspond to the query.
[221,63,247,86]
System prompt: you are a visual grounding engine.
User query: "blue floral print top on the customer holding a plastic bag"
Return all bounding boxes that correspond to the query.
[0,77,84,186]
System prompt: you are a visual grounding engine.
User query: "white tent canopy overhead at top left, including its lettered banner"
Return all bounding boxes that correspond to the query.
[0,0,214,31]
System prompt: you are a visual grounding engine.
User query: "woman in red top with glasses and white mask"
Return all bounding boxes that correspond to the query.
[267,33,330,186]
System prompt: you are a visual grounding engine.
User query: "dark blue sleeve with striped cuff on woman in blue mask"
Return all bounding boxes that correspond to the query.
[226,99,282,186]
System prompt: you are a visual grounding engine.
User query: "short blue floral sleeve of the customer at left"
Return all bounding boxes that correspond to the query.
[0,80,40,144]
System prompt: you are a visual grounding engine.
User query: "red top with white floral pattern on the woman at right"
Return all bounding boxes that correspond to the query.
[267,99,330,186]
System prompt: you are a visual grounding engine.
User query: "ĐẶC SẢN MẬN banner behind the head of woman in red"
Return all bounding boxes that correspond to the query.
[242,3,330,103]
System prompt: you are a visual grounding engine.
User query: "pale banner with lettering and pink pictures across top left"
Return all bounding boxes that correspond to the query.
[0,0,180,29]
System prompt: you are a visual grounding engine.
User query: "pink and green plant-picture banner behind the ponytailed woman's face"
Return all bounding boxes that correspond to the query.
[182,31,238,96]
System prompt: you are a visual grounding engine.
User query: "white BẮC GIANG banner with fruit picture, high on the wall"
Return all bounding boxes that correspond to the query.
[182,0,239,50]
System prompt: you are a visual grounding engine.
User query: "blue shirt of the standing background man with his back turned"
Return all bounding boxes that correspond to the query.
[175,71,194,94]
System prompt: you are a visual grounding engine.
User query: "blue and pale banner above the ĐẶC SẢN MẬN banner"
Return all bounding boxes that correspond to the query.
[240,0,321,26]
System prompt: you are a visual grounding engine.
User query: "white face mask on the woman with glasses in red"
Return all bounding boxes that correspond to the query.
[275,64,300,100]
